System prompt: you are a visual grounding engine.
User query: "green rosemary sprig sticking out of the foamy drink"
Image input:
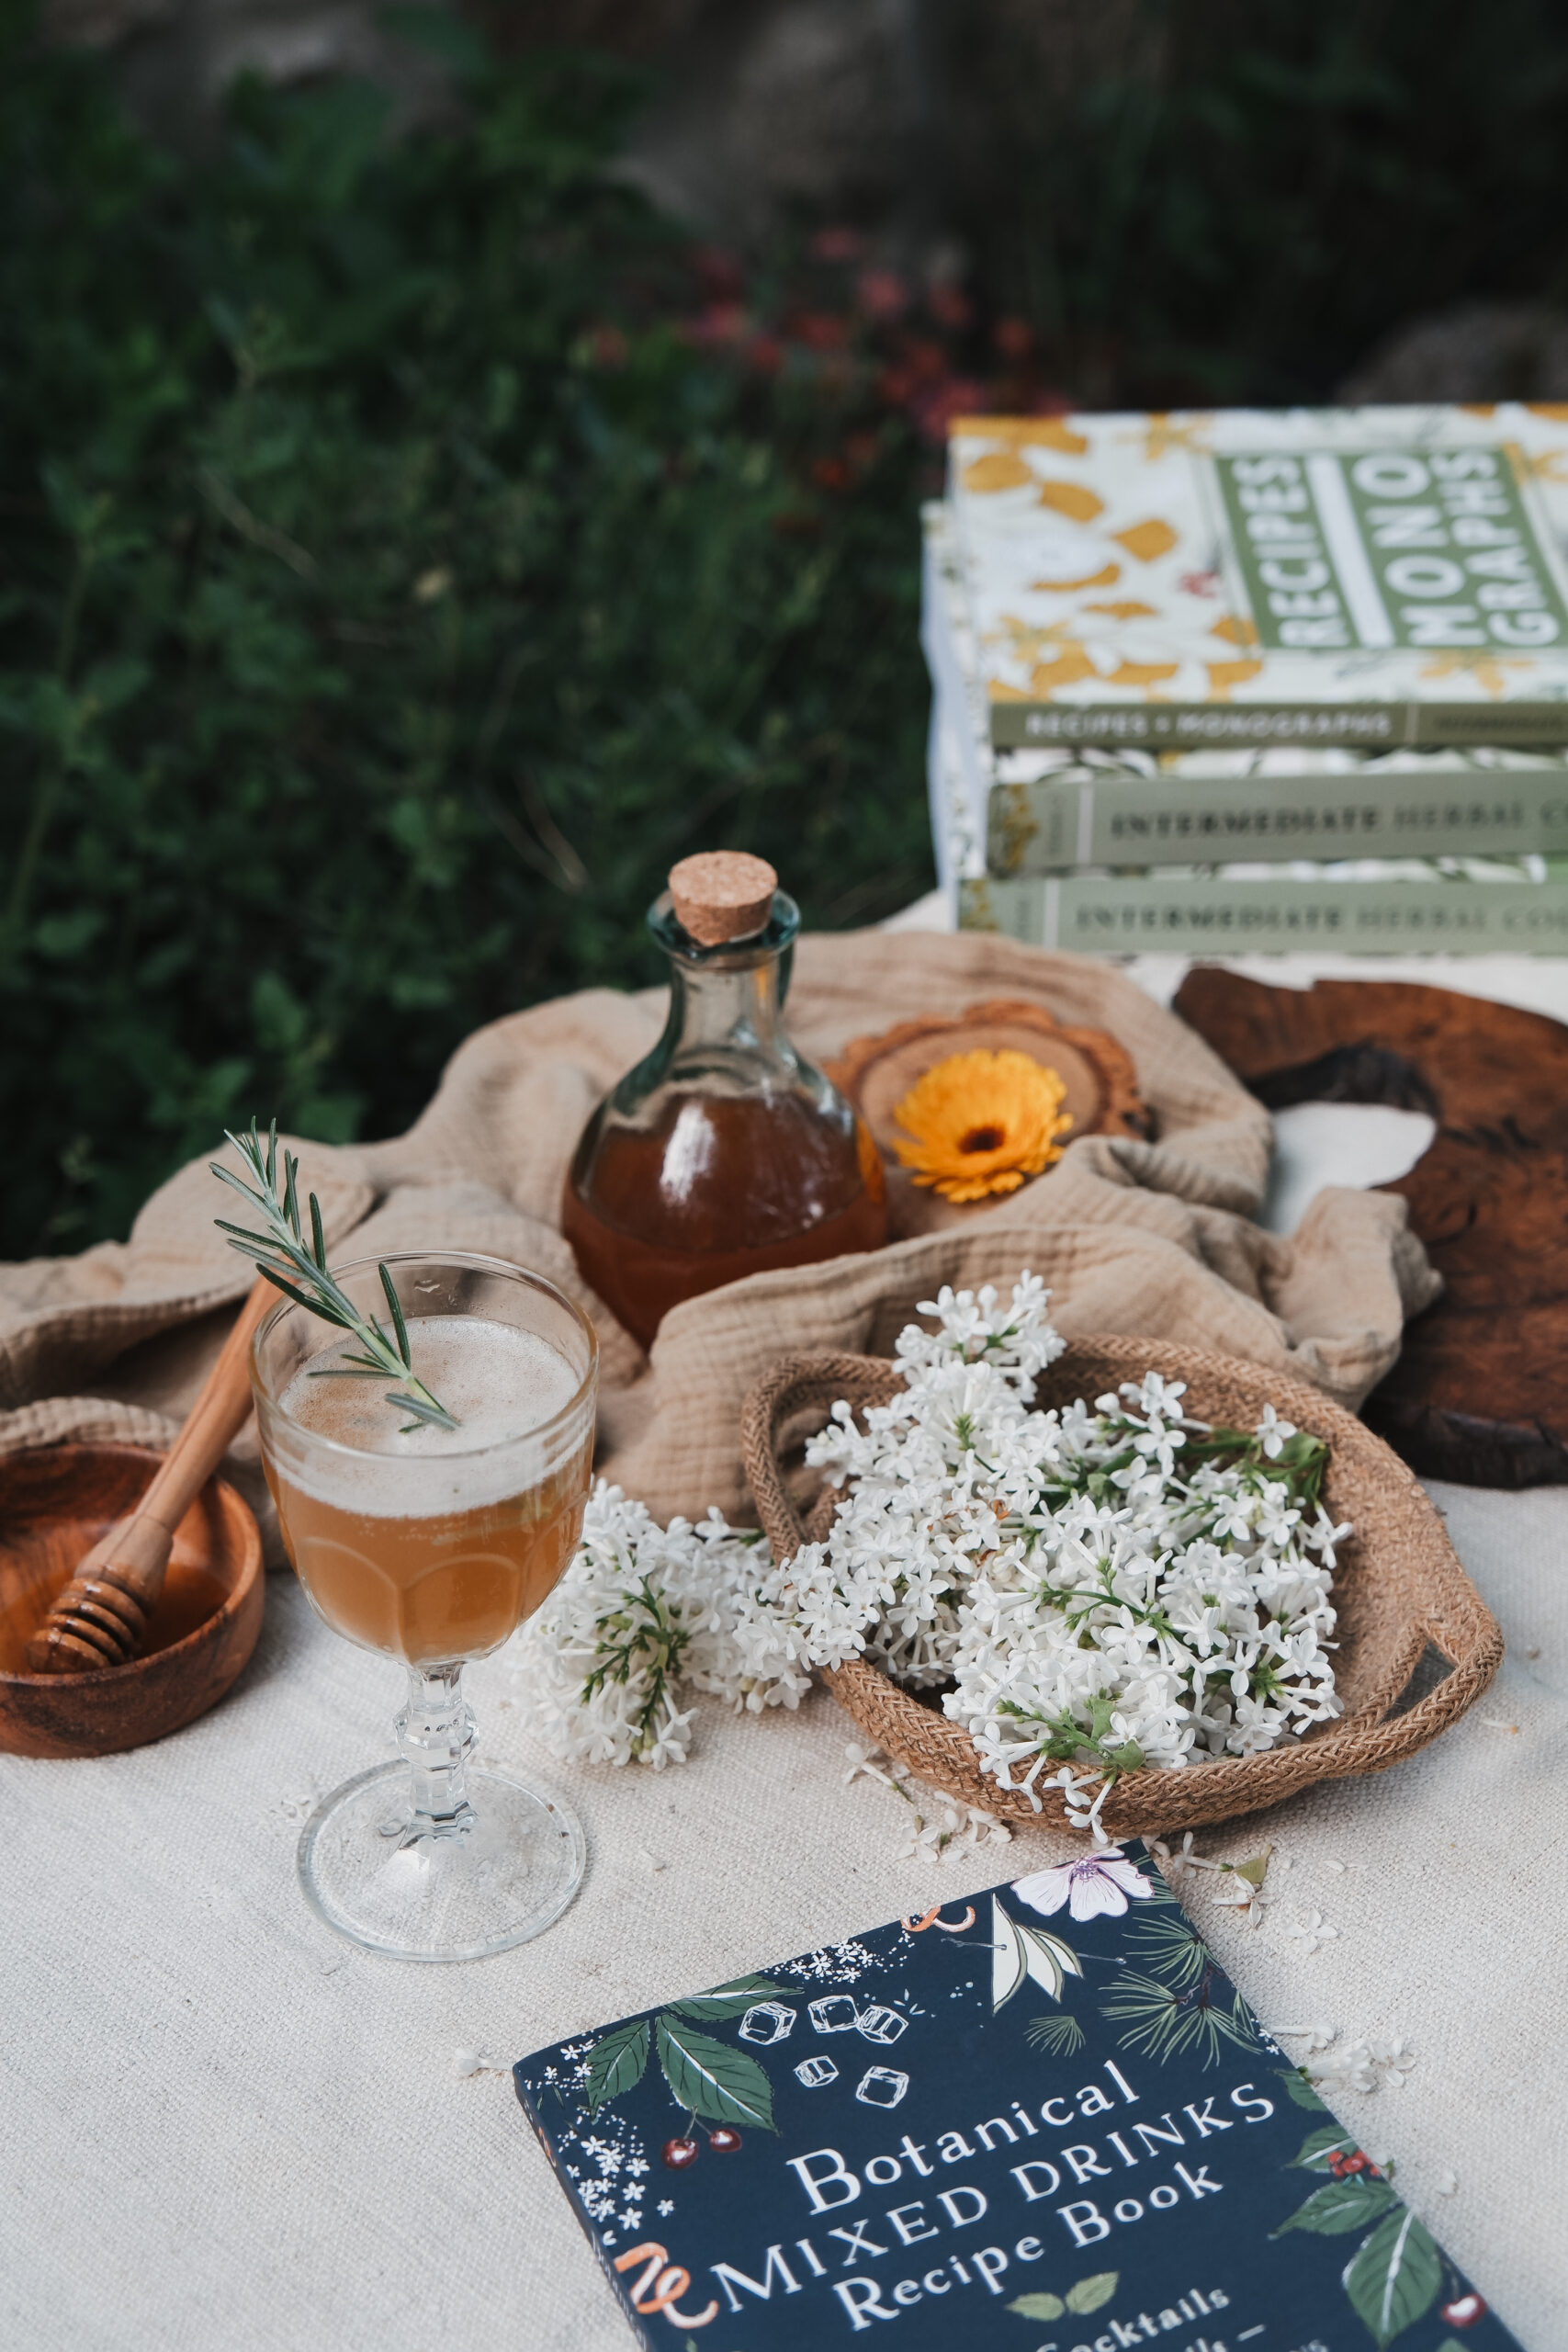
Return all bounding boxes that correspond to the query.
[207,1120,458,1437]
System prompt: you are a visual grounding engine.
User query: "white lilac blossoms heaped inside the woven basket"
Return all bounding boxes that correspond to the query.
[769,1275,1349,1820]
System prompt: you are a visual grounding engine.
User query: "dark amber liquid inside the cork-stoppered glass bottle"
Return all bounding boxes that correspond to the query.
[562,1091,886,1348]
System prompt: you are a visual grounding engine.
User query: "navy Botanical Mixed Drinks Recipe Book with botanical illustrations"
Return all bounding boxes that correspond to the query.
[513,1849,1514,2352]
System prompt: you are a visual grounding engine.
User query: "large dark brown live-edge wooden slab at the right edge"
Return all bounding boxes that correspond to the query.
[1176,965,1568,1487]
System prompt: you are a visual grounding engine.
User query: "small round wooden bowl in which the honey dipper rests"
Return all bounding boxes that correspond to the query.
[0,1446,265,1757]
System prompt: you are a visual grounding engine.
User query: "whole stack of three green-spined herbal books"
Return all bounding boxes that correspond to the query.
[924,404,1568,955]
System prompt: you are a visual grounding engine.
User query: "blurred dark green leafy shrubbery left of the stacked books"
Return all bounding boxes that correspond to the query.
[0,0,959,1253]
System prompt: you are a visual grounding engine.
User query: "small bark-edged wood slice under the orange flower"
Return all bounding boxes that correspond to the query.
[823,997,1152,1242]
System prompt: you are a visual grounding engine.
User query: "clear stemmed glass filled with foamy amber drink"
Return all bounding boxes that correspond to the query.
[252,1251,600,1959]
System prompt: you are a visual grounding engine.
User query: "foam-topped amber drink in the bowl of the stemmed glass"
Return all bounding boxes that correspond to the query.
[268,1315,592,1665]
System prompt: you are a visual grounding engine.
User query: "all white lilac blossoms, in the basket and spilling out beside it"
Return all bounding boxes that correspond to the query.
[514,1275,1349,1832]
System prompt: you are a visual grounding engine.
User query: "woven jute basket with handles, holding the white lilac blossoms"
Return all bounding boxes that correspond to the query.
[740,1339,1502,1837]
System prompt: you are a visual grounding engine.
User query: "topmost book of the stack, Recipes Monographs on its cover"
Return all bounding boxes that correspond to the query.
[950,402,1568,751]
